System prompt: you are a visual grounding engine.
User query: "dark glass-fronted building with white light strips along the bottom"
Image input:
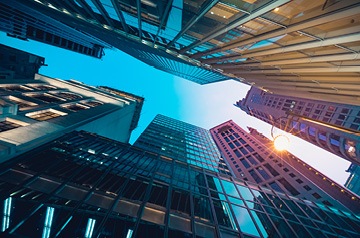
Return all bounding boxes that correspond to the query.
[0,132,360,238]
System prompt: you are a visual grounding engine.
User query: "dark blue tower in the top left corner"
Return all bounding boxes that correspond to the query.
[0,0,111,58]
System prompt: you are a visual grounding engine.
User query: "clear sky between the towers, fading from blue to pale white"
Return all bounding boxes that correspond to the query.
[0,32,350,185]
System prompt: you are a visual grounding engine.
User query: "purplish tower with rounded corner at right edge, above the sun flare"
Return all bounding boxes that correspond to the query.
[236,87,360,164]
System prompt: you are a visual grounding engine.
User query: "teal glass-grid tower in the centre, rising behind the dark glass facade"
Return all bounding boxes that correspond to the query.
[134,115,232,175]
